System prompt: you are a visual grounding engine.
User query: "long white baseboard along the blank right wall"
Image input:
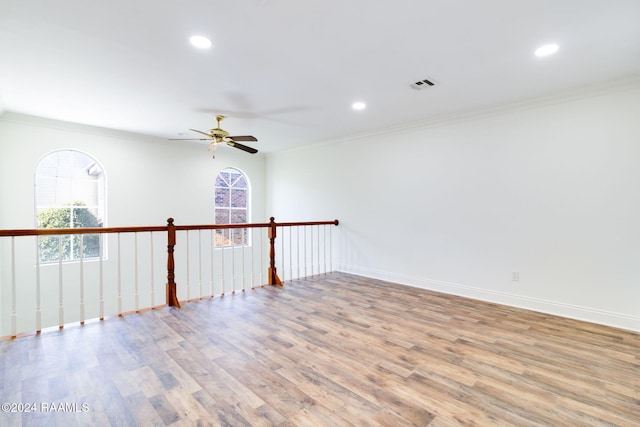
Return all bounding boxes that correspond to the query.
[337,265,640,332]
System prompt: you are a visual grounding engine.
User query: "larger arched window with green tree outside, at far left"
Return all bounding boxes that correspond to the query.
[35,150,105,263]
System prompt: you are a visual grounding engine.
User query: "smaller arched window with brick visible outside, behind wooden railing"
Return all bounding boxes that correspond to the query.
[215,168,250,246]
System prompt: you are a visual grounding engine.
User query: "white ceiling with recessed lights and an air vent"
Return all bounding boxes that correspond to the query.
[0,0,640,152]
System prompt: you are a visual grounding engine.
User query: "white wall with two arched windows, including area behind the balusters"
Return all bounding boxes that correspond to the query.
[0,114,270,336]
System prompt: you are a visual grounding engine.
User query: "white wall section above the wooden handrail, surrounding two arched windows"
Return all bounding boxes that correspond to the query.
[0,114,268,228]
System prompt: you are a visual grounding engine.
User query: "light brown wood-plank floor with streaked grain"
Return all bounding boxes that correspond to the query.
[0,273,640,427]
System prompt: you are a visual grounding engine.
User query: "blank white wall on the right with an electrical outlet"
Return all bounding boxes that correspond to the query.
[267,81,640,330]
